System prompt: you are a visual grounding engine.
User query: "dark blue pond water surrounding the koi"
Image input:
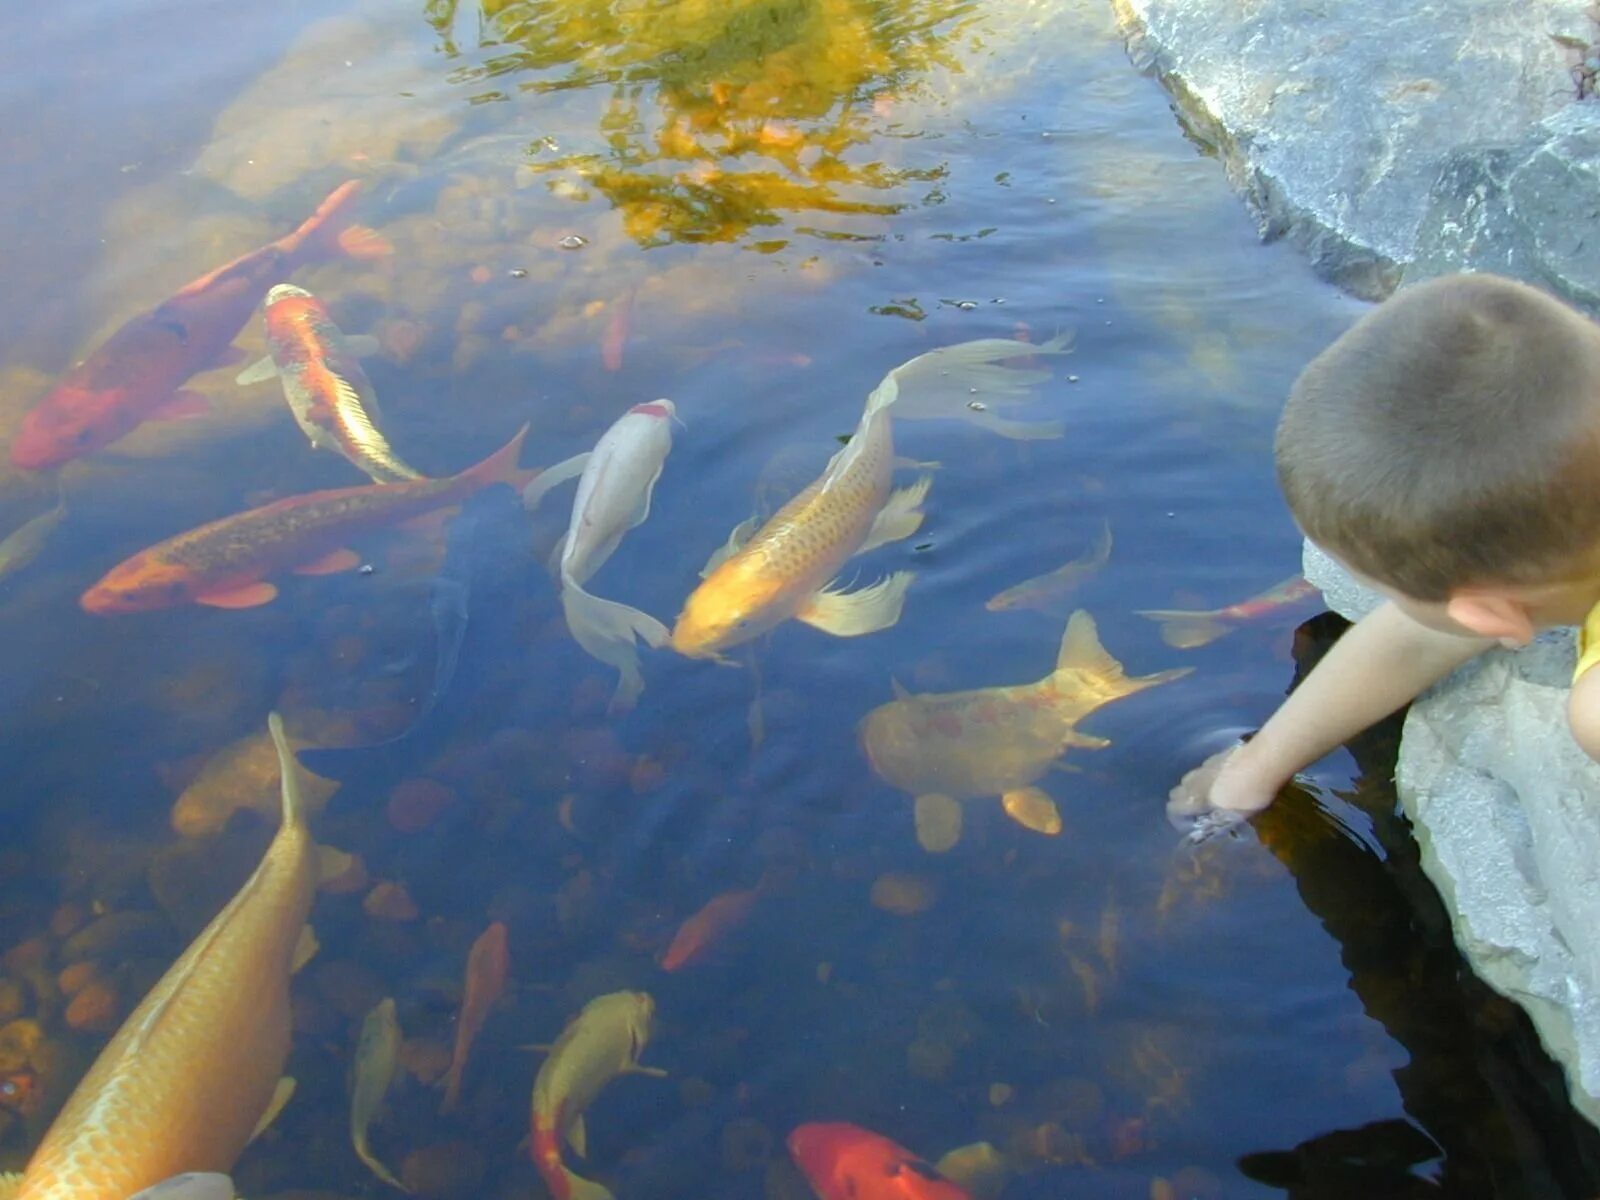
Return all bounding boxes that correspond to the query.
[0,0,1600,1200]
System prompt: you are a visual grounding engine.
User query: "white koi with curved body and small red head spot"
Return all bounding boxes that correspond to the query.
[523,400,677,712]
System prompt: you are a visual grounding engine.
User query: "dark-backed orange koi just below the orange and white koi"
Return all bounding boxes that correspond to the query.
[78,426,536,614]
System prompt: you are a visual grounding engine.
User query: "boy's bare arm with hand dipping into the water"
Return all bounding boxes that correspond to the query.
[1166,602,1494,832]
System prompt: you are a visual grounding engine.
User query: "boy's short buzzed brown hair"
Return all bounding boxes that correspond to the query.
[1277,275,1600,600]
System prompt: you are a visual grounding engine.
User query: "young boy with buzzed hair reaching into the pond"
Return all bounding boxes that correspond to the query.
[1168,275,1600,840]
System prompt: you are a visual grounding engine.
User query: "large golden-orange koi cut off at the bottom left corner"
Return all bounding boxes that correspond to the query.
[0,714,317,1200]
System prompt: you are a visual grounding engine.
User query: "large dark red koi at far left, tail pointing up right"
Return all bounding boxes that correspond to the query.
[11,179,390,469]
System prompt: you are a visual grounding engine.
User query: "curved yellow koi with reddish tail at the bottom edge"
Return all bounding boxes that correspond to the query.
[531,992,667,1200]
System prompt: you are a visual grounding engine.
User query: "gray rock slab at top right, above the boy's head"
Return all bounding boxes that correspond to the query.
[1112,0,1600,299]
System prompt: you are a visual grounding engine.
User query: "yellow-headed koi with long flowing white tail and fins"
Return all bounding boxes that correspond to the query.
[672,338,1066,658]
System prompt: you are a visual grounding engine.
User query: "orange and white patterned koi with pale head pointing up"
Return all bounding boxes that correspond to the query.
[237,283,422,483]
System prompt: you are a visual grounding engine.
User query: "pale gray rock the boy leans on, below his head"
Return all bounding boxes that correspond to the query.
[1304,542,1600,1125]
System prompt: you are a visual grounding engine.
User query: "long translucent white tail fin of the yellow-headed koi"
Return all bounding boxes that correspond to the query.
[866,333,1072,438]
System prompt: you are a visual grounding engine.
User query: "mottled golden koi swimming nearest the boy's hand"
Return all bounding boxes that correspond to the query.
[861,610,1192,850]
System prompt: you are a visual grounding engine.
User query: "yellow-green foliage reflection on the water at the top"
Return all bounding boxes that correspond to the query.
[426,0,974,250]
